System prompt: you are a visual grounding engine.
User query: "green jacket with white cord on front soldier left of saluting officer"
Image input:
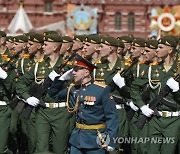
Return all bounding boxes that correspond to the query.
[16,57,62,103]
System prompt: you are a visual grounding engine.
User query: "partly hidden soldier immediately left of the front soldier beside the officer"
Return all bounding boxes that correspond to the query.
[15,33,44,153]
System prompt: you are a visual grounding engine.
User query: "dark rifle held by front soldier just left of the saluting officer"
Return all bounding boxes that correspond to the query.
[22,53,76,119]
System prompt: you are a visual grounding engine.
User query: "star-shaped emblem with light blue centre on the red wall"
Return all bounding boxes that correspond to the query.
[67,5,97,35]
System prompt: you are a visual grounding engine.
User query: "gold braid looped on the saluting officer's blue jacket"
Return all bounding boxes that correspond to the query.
[66,84,80,113]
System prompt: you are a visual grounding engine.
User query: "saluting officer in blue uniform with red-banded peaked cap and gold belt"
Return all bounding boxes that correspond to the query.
[49,56,118,154]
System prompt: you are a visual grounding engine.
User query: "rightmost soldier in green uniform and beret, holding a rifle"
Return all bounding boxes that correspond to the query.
[148,37,180,154]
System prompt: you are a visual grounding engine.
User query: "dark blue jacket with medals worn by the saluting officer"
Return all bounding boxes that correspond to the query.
[48,78,118,149]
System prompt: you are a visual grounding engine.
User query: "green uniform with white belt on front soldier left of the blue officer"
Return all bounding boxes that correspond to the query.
[17,57,70,154]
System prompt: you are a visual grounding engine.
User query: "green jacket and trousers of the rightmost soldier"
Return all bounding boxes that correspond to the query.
[148,59,180,154]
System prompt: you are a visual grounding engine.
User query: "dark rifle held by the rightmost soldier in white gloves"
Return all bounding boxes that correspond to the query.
[136,74,180,130]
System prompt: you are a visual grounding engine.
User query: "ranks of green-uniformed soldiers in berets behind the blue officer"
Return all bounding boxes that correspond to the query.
[0,31,180,154]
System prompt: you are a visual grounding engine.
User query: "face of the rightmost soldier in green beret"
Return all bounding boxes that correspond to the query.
[157,44,172,59]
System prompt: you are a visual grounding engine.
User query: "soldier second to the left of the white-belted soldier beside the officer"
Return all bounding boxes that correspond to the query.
[8,35,33,153]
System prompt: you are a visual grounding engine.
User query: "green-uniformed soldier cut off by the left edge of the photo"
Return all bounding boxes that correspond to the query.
[0,31,12,154]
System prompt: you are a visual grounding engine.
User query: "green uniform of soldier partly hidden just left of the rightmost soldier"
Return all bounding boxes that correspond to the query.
[129,60,153,154]
